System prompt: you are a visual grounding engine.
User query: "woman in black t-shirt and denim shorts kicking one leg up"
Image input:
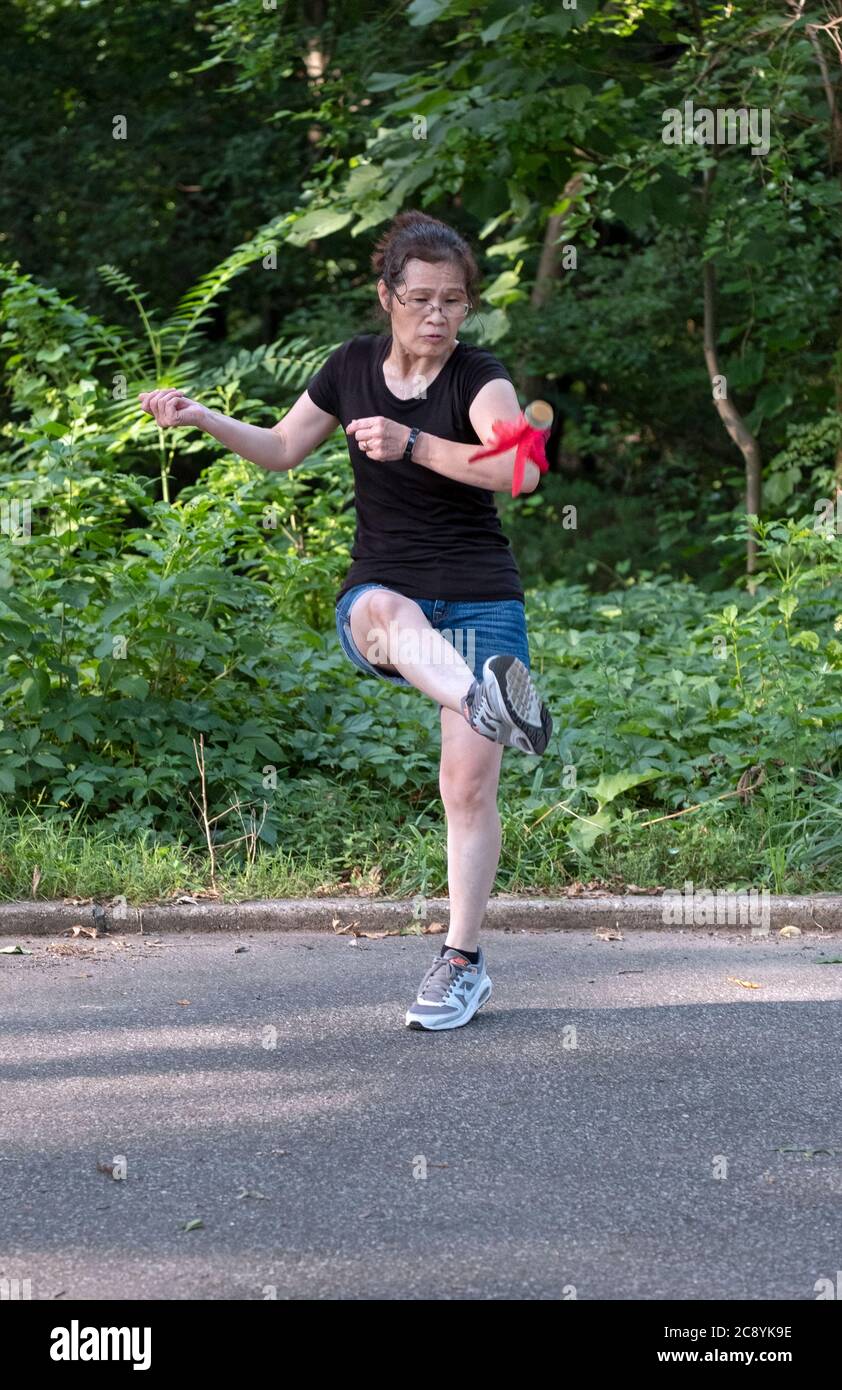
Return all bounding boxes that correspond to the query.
[140,211,552,1031]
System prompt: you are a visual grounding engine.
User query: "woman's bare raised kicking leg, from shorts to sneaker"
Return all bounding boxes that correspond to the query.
[349,588,474,717]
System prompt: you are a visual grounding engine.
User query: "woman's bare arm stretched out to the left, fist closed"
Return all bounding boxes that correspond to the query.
[139,389,339,473]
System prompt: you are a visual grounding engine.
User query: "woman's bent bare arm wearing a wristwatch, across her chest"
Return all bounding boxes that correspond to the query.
[347,378,540,492]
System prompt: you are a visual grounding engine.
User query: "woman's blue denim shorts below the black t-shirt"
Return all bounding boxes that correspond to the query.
[336,584,529,685]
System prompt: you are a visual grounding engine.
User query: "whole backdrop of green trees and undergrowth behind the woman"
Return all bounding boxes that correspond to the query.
[0,0,842,891]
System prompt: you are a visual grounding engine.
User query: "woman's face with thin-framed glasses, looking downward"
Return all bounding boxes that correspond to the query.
[378,260,468,357]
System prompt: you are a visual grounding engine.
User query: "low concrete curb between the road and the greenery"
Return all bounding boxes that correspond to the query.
[0,890,842,937]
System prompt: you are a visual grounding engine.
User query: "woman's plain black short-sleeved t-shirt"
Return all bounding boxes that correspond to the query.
[307,334,524,600]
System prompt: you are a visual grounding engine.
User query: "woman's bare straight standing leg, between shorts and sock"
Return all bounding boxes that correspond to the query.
[439,708,503,952]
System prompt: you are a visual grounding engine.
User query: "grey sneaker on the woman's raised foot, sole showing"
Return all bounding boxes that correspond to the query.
[463,656,553,753]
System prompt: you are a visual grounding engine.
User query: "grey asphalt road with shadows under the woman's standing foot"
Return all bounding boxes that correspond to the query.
[0,929,842,1300]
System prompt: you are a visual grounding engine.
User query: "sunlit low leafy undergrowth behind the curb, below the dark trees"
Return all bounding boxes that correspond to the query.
[0,261,842,887]
